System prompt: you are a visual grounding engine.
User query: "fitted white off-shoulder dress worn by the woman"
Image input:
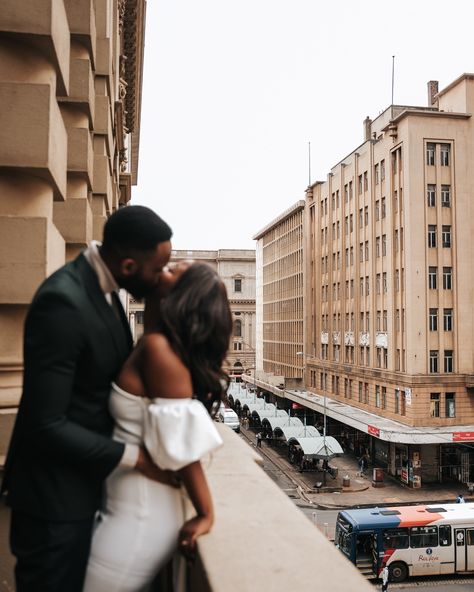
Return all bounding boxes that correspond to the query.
[84,384,222,592]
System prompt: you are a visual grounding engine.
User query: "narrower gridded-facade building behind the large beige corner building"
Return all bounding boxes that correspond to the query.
[254,200,305,386]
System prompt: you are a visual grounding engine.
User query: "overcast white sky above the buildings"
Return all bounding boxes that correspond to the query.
[133,0,474,249]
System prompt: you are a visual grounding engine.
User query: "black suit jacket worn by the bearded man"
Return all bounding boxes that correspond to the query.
[3,255,132,521]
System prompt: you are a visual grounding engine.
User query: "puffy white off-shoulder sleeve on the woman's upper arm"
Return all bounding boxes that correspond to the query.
[143,399,222,471]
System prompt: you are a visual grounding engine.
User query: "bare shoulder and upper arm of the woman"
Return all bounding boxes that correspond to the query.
[141,333,193,398]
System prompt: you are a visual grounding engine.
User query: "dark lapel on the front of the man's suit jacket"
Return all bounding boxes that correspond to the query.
[75,254,132,358]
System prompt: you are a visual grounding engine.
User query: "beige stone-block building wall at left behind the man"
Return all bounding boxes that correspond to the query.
[0,0,145,455]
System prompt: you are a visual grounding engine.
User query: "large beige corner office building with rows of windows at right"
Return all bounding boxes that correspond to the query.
[305,75,474,485]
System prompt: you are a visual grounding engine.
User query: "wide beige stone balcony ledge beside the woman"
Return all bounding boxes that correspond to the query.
[190,424,373,592]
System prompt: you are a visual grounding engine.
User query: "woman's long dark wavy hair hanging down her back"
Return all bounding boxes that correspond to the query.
[158,263,232,411]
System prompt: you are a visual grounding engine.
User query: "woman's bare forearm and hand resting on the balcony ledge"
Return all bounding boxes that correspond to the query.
[179,461,214,558]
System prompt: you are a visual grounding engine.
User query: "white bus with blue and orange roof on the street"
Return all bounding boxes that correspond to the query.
[334,503,474,582]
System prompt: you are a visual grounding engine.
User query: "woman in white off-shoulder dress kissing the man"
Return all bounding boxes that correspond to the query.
[84,263,232,592]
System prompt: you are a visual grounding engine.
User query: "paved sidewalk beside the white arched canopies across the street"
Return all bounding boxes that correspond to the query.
[241,429,474,509]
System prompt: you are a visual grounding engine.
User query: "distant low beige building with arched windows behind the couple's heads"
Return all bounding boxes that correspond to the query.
[129,249,255,375]
